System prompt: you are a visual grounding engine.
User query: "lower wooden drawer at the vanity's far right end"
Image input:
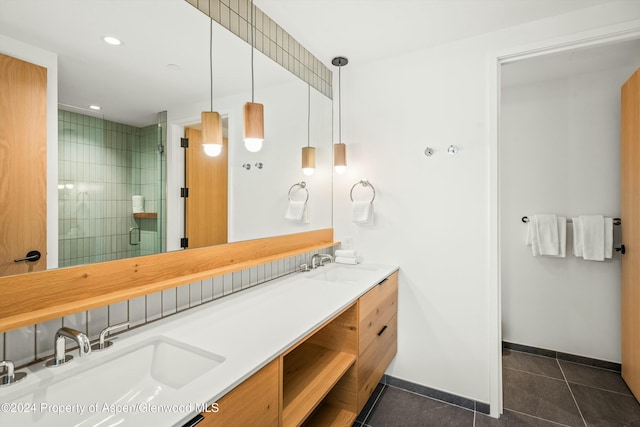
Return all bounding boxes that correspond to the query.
[358,315,398,411]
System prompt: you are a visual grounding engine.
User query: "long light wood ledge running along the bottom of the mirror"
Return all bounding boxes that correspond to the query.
[0,228,339,332]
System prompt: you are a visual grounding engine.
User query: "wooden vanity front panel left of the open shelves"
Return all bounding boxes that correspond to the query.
[198,360,280,427]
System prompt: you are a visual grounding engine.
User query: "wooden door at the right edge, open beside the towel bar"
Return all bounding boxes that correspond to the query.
[620,69,640,399]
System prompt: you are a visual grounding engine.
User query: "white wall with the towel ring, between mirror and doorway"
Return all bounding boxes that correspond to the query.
[334,2,640,409]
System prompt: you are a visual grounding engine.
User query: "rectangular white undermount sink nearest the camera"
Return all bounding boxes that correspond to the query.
[0,337,225,427]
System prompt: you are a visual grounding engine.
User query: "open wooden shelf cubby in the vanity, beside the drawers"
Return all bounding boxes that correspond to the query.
[282,342,356,426]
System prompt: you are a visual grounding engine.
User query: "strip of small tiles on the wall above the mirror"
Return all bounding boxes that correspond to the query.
[186,0,333,99]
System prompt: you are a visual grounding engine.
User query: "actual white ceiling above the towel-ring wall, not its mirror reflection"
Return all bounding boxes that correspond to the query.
[254,0,616,65]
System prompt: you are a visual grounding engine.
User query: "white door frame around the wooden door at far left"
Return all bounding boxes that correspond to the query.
[0,34,58,269]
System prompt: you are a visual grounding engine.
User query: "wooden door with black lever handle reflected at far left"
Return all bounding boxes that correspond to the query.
[0,54,47,276]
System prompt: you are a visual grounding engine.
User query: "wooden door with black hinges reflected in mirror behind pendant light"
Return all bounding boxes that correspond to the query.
[185,128,229,248]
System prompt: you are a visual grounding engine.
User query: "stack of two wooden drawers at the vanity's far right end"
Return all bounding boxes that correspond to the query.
[357,272,398,412]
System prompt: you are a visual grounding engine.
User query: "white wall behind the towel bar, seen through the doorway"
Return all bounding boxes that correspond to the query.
[500,64,640,362]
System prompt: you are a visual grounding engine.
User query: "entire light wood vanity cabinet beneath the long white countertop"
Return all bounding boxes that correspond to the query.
[198,272,398,427]
